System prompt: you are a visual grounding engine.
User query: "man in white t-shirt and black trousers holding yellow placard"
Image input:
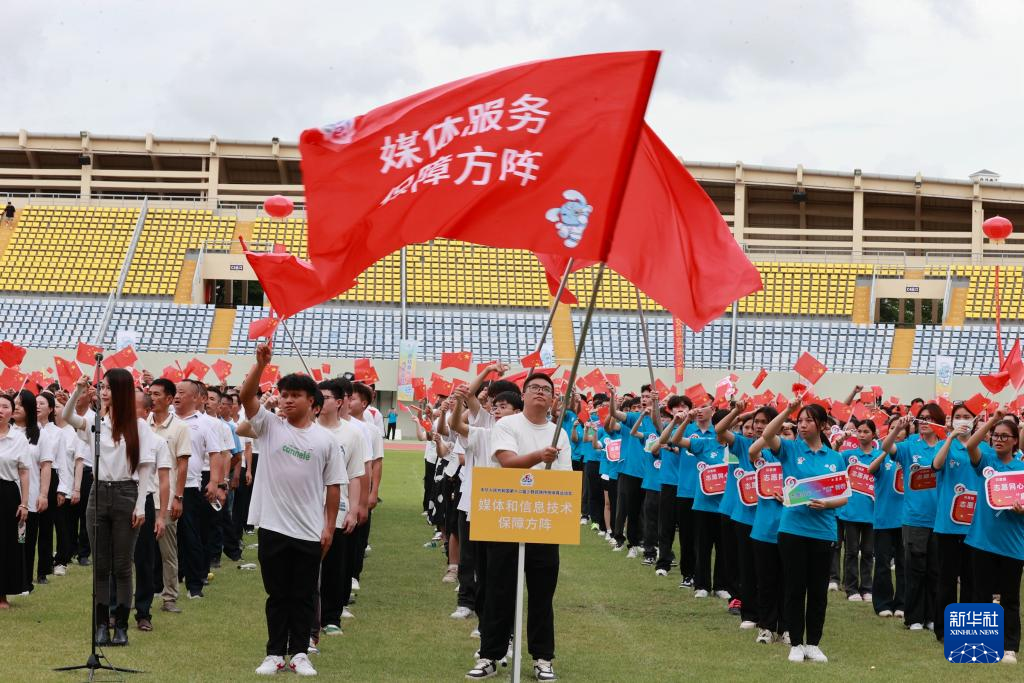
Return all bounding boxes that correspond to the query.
[466,374,572,681]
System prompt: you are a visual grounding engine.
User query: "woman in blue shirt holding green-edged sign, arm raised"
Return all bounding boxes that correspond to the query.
[752,398,847,663]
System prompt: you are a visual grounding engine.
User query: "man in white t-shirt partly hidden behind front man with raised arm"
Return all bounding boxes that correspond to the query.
[315,379,370,636]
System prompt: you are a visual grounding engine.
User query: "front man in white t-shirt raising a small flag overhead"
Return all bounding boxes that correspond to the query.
[239,344,348,676]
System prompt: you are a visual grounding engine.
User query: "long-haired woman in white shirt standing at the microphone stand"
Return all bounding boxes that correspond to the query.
[63,369,155,645]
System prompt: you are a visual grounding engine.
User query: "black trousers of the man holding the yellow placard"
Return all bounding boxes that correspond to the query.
[480,542,558,660]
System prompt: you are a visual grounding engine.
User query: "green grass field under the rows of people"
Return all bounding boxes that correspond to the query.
[0,452,1024,681]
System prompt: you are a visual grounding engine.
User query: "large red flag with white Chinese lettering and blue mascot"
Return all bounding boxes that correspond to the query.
[299,51,660,295]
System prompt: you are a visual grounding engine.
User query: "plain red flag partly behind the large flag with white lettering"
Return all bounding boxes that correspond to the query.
[537,125,762,331]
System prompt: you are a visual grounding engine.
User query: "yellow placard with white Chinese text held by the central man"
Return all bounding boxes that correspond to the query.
[469,467,583,546]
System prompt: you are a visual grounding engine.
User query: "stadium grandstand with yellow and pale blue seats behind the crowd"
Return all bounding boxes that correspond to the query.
[0,130,1024,421]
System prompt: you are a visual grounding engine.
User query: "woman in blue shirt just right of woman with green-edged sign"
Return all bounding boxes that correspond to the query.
[837,420,876,602]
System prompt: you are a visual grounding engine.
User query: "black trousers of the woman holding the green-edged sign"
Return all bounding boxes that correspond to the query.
[778,533,831,645]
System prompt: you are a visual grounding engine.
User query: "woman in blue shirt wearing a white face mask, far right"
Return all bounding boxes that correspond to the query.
[932,403,992,642]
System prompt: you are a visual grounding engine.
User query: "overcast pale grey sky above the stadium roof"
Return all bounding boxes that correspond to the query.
[0,0,1024,182]
